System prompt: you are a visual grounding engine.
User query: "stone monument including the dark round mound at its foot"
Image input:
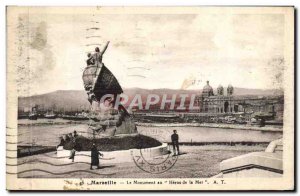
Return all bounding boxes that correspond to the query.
[58,42,162,152]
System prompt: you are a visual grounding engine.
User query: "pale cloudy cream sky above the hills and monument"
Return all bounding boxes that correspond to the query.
[12,7,284,96]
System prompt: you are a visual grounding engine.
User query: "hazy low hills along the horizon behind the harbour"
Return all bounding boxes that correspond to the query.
[18,88,283,111]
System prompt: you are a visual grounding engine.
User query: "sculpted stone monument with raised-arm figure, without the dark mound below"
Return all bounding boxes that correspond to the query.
[82,42,137,138]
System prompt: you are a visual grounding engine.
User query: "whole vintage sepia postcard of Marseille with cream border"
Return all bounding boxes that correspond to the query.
[6,6,295,191]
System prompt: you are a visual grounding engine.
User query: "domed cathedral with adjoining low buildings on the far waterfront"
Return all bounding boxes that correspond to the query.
[199,81,283,118]
